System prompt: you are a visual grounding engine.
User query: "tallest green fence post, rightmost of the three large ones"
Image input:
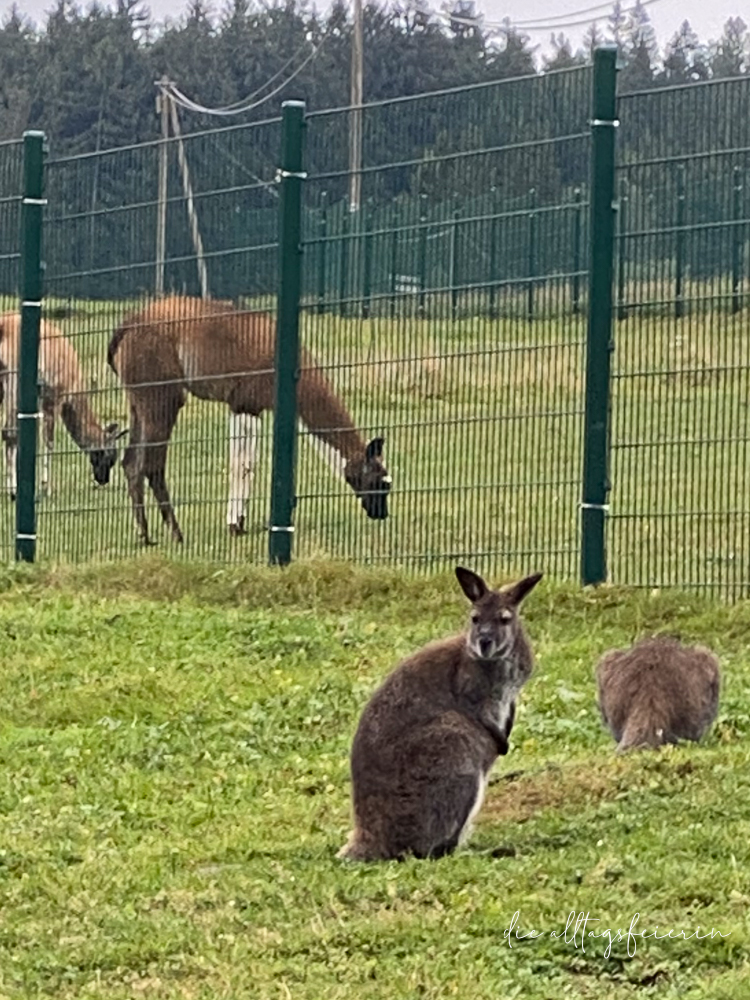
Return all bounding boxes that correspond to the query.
[581,46,617,585]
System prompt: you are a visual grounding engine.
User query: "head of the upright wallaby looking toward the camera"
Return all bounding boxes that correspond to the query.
[456,566,542,660]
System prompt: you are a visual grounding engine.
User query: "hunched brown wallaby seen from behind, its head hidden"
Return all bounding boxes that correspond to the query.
[596,636,719,751]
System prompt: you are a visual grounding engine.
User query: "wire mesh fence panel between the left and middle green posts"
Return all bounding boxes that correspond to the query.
[38,120,279,560]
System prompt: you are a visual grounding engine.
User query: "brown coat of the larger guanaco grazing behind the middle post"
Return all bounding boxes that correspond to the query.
[107,296,390,541]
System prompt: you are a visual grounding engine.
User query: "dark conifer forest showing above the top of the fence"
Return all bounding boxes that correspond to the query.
[0,0,750,155]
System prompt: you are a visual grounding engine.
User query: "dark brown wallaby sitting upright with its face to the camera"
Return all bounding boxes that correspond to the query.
[339,567,542,861]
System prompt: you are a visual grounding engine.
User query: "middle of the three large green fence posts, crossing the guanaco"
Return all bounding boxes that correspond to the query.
[268,101,305,566]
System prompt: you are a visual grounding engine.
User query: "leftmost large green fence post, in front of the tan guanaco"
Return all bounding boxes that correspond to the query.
[16,132,46,562]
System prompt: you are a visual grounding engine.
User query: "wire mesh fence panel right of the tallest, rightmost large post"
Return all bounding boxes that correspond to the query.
[609,78,750,596]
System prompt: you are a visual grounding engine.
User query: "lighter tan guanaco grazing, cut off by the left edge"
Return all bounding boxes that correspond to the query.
[0,312,121,485]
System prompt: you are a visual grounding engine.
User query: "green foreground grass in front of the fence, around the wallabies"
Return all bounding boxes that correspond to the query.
[0,556,750,1000]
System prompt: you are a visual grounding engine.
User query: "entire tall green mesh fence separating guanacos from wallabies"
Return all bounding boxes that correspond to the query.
[0,56,750,595]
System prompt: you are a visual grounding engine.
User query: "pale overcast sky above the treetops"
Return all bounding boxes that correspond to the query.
[0,0,750,56]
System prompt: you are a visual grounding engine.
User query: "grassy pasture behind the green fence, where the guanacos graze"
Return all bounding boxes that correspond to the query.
[2,286,750,597]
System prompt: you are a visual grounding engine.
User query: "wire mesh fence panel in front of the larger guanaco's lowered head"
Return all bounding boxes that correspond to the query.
[297,69,590,576]
